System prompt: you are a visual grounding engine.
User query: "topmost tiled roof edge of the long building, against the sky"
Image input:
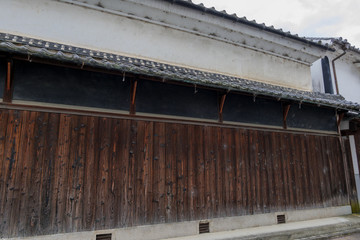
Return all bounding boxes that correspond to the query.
[163,0,333,50]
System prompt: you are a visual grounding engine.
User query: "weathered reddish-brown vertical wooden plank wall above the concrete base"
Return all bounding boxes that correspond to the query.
[0,109,348,237]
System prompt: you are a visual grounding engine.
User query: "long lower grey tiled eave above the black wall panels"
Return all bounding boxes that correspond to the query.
[0,33,360,111]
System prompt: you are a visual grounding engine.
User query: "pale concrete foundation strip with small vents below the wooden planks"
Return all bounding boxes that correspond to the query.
[4,206,351,240]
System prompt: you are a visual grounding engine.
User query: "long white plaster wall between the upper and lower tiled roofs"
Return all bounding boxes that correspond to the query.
[0,0,312,91]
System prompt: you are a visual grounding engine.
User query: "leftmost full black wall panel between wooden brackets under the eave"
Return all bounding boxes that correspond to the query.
[13,61,130,111]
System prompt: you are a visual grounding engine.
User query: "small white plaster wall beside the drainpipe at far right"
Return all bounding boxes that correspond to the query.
[335,58,360,103]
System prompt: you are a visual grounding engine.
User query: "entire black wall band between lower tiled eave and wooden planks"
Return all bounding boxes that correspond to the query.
[2,60,337,132]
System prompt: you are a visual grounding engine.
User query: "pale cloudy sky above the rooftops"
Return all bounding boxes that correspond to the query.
[193,0,360,48]
